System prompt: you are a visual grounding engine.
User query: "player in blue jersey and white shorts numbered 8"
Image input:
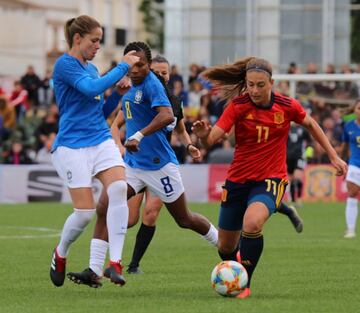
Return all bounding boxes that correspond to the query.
[68,42,217,287]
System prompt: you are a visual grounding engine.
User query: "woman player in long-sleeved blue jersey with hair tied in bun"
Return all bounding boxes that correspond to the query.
[50,15,139,287]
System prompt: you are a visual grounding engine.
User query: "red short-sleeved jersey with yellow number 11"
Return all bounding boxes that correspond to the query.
[216,93,306,183]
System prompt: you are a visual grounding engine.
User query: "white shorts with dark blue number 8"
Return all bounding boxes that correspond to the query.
[125,163,184,203]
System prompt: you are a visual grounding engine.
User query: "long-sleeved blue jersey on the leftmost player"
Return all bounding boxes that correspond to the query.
[52,53,129,151]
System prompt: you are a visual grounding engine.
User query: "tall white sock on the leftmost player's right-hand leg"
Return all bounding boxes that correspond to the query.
[106,180,129,262]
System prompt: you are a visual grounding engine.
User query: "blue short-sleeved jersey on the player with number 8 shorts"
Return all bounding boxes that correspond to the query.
[122,72,179,170]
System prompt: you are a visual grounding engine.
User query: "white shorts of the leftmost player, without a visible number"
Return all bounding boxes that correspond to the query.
[51,139,125,188]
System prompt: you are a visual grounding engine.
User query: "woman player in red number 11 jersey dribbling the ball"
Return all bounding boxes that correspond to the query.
[193,57,347,298]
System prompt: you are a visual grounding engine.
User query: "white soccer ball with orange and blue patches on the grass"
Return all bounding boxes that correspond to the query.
[211,261,248,297]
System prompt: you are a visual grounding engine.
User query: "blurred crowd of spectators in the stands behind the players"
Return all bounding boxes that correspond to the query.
[0,59,360,164]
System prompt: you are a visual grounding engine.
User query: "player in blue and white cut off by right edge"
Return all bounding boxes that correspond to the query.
[342,99,360,238]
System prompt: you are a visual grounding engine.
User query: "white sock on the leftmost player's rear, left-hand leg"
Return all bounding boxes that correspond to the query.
[57,209,95,258]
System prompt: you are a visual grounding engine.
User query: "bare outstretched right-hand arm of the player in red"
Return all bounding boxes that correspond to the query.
[302,115,347,177]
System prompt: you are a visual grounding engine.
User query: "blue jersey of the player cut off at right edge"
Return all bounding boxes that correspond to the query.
[342,120,360,167]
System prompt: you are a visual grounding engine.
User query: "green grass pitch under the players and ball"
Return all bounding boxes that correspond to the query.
[0,203,360,313]
